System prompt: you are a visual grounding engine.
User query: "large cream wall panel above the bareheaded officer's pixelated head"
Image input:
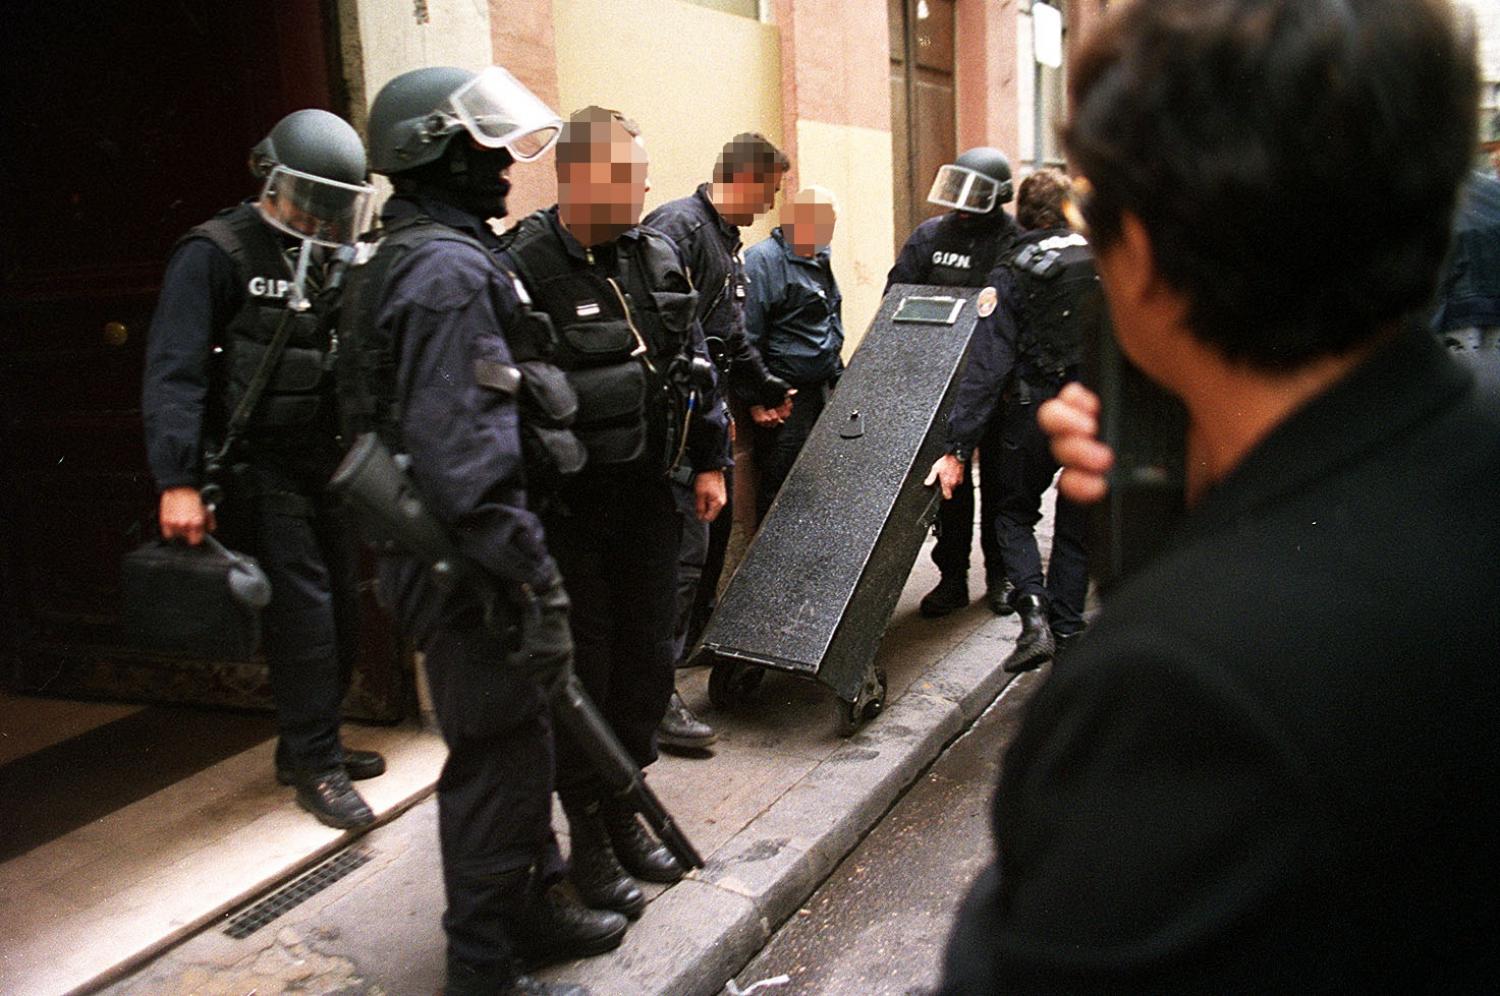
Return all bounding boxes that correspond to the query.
[552,0,786,245]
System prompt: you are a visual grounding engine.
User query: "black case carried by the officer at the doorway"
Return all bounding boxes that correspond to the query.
[122,536,270,660]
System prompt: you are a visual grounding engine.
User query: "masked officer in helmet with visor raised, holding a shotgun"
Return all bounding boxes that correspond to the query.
[339,68,626,993]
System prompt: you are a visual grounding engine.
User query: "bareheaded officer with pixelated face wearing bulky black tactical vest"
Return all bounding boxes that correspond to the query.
[501,107,729,917]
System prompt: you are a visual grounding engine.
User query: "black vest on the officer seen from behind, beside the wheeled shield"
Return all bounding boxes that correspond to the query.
[1011,228,1104,380]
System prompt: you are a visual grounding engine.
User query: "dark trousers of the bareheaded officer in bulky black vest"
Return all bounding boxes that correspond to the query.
[543,470,683,795]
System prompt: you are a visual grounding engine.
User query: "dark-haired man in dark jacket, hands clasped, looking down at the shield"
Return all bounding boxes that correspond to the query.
[644,132,792,749]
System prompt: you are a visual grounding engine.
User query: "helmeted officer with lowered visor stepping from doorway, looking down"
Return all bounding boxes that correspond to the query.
[141,110,386,828]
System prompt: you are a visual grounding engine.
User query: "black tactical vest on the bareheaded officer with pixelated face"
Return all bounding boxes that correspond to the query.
[506,212,698,470]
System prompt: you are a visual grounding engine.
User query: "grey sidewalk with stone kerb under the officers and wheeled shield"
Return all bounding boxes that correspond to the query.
[110,528,1019,996]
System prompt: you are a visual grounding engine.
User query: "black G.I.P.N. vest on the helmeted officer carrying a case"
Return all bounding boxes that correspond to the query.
[183,204,338,446]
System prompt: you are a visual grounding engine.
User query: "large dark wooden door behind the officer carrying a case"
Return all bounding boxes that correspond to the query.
[0,0,401,719]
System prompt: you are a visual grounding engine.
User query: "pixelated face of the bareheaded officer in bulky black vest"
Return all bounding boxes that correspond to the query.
[558,122,650,238]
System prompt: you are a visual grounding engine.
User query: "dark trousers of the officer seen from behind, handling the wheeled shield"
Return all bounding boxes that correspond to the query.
[990,390,1089,633]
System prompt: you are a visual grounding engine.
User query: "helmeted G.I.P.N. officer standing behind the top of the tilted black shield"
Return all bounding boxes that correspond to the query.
[885,147,1017,617]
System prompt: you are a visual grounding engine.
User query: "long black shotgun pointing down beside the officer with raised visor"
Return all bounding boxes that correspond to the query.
[329,432,704,869]
